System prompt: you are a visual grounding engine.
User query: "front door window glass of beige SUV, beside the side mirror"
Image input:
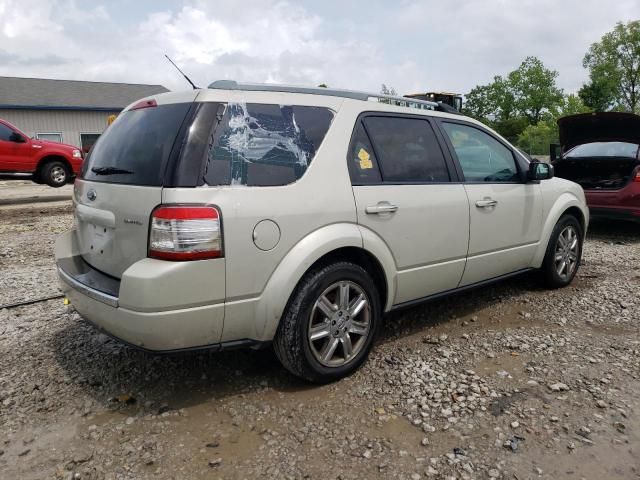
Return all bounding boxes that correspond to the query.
[442,122,520,183]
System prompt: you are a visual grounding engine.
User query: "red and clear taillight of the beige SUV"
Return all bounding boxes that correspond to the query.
[149,205,222,261]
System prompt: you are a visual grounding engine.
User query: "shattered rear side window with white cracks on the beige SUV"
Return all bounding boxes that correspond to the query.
[204,103,333,186]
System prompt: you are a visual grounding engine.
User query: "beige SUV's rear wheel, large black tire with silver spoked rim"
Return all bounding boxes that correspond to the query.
[274,262,382,383]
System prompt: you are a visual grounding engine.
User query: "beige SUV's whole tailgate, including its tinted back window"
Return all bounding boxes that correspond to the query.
[74,92,197,278]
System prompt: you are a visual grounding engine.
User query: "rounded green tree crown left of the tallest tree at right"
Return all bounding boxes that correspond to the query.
[507,57,562,125]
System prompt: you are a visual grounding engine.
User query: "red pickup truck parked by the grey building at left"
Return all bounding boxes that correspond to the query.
[0,120,83,187]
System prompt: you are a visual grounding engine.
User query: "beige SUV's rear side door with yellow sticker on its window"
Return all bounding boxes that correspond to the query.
[348,113,469,304]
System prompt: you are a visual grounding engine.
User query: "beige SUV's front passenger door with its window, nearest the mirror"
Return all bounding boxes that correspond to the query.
[440,120,543,286]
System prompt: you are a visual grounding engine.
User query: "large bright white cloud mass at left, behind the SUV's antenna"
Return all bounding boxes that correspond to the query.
[0,0,418,91]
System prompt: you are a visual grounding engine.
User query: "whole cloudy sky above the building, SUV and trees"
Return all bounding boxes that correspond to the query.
[0,0,640,94]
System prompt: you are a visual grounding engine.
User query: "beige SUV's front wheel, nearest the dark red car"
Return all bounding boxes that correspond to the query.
[540,215,584,288]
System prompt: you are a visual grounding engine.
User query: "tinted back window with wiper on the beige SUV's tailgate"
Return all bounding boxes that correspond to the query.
[82,103,191,186]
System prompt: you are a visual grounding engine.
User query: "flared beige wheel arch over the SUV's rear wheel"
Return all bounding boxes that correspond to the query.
[255,223,395,340]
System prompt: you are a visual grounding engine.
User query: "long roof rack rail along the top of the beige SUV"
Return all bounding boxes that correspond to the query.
[209,80,443,111]
